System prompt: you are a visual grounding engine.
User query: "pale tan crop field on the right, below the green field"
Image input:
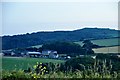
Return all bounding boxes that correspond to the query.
[93,46,120,53]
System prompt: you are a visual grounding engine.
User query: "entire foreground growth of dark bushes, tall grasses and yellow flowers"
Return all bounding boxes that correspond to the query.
[2,54,120,80]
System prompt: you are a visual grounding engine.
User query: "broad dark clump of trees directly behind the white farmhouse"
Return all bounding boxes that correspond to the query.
[42,41,83,56]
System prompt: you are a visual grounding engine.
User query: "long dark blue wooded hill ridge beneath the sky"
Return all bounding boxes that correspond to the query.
[2,28,120,50]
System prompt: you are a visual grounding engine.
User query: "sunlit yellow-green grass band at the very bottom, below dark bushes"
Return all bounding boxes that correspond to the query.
[2,70,120,80]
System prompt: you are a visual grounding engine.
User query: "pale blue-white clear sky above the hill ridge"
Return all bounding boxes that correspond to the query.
[0,0,118,35]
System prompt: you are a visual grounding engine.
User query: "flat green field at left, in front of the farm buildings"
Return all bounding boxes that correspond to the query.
[2,57,64,70]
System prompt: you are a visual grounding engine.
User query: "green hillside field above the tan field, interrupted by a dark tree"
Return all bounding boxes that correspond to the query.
[75,38,120,46]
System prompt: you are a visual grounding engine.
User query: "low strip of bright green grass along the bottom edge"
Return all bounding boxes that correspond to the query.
[2,70,120,80]
